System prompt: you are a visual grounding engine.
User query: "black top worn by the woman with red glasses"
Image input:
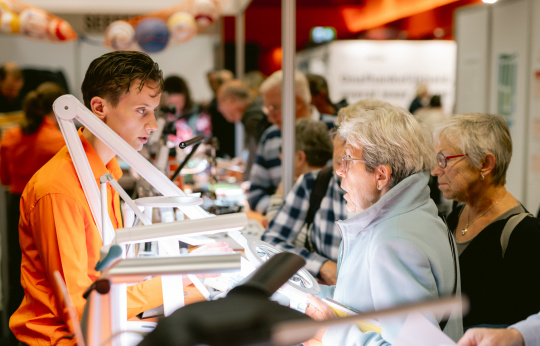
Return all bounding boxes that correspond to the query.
[448,206,540,328]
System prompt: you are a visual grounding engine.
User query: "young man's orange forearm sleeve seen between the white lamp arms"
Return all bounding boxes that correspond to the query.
[127,276,163,319]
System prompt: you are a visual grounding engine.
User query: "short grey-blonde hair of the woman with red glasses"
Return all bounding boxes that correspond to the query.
[433,113,512,185]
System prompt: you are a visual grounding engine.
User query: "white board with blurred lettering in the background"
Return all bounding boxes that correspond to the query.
[297,40,456,113]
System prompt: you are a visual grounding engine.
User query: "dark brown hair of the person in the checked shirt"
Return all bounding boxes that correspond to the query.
[295,118,333,167]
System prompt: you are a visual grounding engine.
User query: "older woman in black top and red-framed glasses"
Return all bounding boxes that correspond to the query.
[431,113,540,327]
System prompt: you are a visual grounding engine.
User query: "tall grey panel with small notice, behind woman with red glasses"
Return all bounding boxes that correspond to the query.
[488,0,530,202]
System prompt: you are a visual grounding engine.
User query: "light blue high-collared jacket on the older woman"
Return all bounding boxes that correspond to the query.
[321,172,463,345]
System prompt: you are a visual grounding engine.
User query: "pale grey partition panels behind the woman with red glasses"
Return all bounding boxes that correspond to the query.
[455,0,540,214]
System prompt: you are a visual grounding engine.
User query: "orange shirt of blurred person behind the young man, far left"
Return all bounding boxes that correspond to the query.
[0,117,65,194]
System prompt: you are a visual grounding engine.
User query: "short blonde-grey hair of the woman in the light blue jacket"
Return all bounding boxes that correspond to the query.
[338,100,435,187]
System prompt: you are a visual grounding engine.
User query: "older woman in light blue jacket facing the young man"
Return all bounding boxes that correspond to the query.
[307,103,463,345]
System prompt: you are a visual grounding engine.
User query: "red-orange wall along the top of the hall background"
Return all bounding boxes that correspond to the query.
[224,0,481,75]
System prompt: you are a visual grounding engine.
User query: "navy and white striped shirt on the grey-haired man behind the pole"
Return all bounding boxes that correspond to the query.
[247,111,336,214]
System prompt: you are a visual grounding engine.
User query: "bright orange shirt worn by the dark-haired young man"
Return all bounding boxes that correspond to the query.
[9,130,163,345]
